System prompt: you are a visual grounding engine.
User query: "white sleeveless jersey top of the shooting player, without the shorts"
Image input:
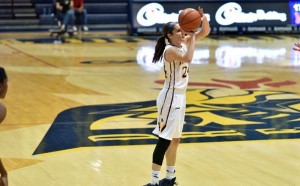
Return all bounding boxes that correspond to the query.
[162,44,189,91]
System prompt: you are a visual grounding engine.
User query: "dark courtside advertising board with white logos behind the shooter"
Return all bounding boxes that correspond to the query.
[130,0,300,34]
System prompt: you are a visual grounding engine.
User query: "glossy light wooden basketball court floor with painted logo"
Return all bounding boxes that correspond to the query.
[0,33,300,186]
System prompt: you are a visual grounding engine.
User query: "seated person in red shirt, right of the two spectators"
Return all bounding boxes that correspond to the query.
[73,0,89,31]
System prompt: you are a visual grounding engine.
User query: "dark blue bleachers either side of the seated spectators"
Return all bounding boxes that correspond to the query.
[0,0,128,32]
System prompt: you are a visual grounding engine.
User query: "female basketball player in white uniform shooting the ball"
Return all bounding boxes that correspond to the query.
[145,8,210,186]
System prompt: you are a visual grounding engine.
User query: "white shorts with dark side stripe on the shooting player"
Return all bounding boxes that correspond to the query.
[153,89,186,140]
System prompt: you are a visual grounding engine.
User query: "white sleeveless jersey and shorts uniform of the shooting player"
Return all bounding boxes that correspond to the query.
[153,45,188,140]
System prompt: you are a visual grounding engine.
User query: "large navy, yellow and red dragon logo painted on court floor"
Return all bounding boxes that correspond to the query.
[33,78,300,154]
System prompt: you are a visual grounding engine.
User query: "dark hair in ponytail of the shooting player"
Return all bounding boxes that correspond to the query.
[152,22,176,63]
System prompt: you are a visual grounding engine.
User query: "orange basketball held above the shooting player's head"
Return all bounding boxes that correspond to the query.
[178,8,201,32]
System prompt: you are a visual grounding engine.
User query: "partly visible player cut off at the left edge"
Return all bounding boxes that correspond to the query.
[0,67,8,186]
